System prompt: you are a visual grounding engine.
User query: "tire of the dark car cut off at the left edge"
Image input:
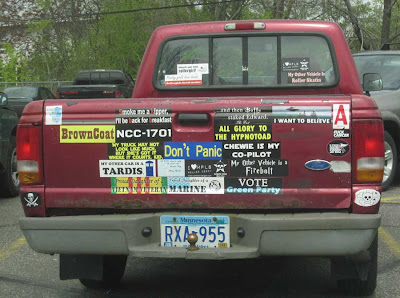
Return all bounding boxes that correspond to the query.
[0,137,21,197]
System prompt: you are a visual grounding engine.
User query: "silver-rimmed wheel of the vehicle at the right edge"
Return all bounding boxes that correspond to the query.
[382,131,398,190]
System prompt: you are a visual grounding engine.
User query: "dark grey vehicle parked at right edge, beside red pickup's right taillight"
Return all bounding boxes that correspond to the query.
[353,51,400,189]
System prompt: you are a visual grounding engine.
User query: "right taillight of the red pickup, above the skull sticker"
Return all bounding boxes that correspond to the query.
[352,120,385,183]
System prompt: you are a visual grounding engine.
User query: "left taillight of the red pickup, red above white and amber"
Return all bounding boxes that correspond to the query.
[17,125,43,185]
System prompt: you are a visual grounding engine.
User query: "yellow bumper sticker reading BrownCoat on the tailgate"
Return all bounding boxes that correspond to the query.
[60,125,115,143]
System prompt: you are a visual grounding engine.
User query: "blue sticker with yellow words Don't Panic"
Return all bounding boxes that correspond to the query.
[164,142,222,159]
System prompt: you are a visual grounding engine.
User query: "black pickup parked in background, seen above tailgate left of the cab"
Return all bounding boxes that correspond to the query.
[57,69,135,99]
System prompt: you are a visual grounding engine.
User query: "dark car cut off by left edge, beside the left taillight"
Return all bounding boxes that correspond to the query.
[0,92,20,197]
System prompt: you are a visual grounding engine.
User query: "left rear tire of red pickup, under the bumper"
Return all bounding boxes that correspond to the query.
[79,256,128,289]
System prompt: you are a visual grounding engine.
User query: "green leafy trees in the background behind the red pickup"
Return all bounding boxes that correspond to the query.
[4,0,400,81]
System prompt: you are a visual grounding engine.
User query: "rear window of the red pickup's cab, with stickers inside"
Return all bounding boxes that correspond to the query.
[153,34,338,90]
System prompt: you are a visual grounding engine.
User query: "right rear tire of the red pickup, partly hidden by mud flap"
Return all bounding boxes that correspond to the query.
[337,234,378,296]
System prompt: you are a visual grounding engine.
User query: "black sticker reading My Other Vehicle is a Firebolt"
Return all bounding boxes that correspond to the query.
[230,159,289,177]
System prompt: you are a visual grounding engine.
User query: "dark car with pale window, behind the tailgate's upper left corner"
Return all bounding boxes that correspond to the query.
[4,86,56,117]
